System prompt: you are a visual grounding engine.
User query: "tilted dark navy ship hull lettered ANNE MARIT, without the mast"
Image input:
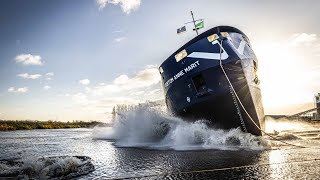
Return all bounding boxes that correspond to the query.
[159,26,265,136]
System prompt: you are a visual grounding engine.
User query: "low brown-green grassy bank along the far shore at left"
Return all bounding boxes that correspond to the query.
[0,120,107,131]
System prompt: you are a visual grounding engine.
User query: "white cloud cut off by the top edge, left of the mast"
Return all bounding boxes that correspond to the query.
[96,0,141,14]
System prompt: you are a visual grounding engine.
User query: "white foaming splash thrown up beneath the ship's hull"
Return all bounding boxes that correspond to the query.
[93,106,269,150]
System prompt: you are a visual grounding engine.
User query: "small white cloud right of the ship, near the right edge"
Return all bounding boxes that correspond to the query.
[290,33,317,46]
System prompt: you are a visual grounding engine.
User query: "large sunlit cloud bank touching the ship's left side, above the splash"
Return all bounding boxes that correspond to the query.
[67,66,163,120]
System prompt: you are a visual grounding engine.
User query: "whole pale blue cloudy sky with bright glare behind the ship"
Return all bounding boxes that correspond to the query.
[0,0,320,122]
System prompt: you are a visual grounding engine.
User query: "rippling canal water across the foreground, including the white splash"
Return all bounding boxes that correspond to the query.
[0,107,320,179]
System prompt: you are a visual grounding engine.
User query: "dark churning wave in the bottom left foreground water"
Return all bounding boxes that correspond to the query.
[0,156,94,179]
